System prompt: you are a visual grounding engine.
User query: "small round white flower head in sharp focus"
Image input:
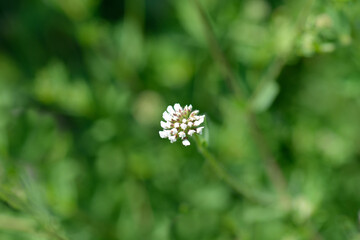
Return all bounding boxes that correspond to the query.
[159,103,205,146]
